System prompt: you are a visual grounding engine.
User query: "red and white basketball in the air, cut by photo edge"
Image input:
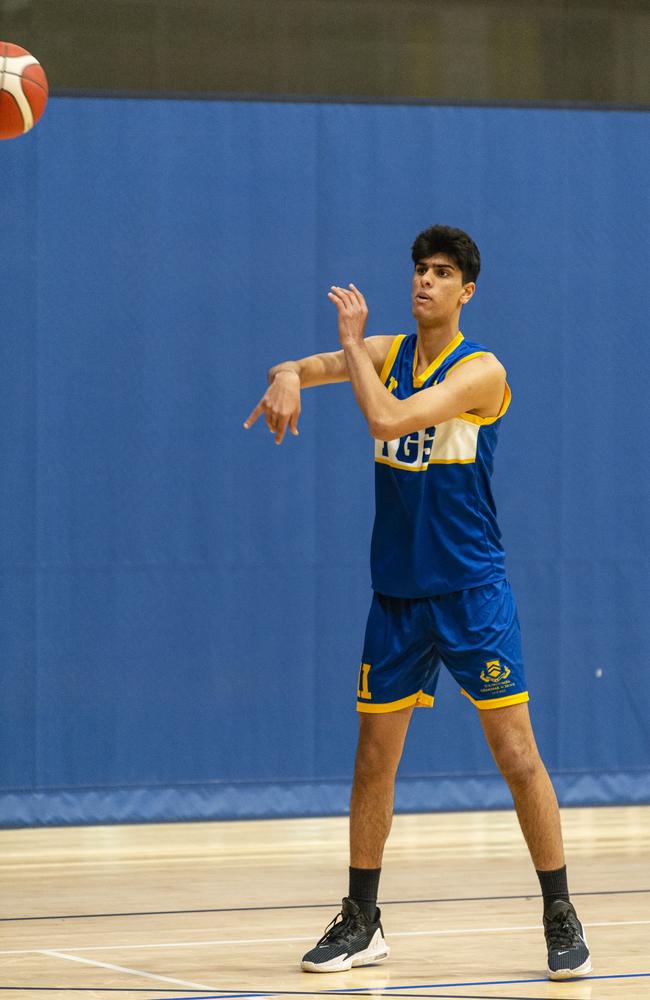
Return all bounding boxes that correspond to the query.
[0,42,48,139]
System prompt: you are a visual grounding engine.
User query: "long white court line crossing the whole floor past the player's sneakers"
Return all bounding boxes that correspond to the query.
[0,920,650,956]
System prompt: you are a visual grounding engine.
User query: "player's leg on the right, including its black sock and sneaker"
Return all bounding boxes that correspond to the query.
[479,704,591,980]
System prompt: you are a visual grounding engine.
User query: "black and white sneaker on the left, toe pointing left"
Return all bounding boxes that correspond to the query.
[301,896,390,972]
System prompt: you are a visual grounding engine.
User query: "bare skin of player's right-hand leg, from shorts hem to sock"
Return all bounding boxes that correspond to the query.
[478,703,564,870]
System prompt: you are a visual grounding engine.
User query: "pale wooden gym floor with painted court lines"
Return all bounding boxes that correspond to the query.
[0,806,650,1000]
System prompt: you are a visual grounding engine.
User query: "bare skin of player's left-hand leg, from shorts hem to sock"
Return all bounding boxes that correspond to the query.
[350,708,413,868]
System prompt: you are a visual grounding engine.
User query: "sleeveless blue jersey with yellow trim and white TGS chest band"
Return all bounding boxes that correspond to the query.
[371,333,510,597]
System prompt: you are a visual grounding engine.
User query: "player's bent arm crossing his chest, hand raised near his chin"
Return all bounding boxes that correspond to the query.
[328,285,506,441]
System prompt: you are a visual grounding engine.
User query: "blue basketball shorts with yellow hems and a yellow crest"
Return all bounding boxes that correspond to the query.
[357,580,528,712]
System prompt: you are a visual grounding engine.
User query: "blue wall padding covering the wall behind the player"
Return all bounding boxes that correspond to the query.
[0,99,650,825]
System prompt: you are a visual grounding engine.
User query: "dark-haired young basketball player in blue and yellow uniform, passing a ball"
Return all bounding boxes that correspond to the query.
[244,226,591,979]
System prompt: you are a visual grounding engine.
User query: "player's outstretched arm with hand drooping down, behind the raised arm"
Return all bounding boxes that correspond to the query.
[244,335,395,444]
